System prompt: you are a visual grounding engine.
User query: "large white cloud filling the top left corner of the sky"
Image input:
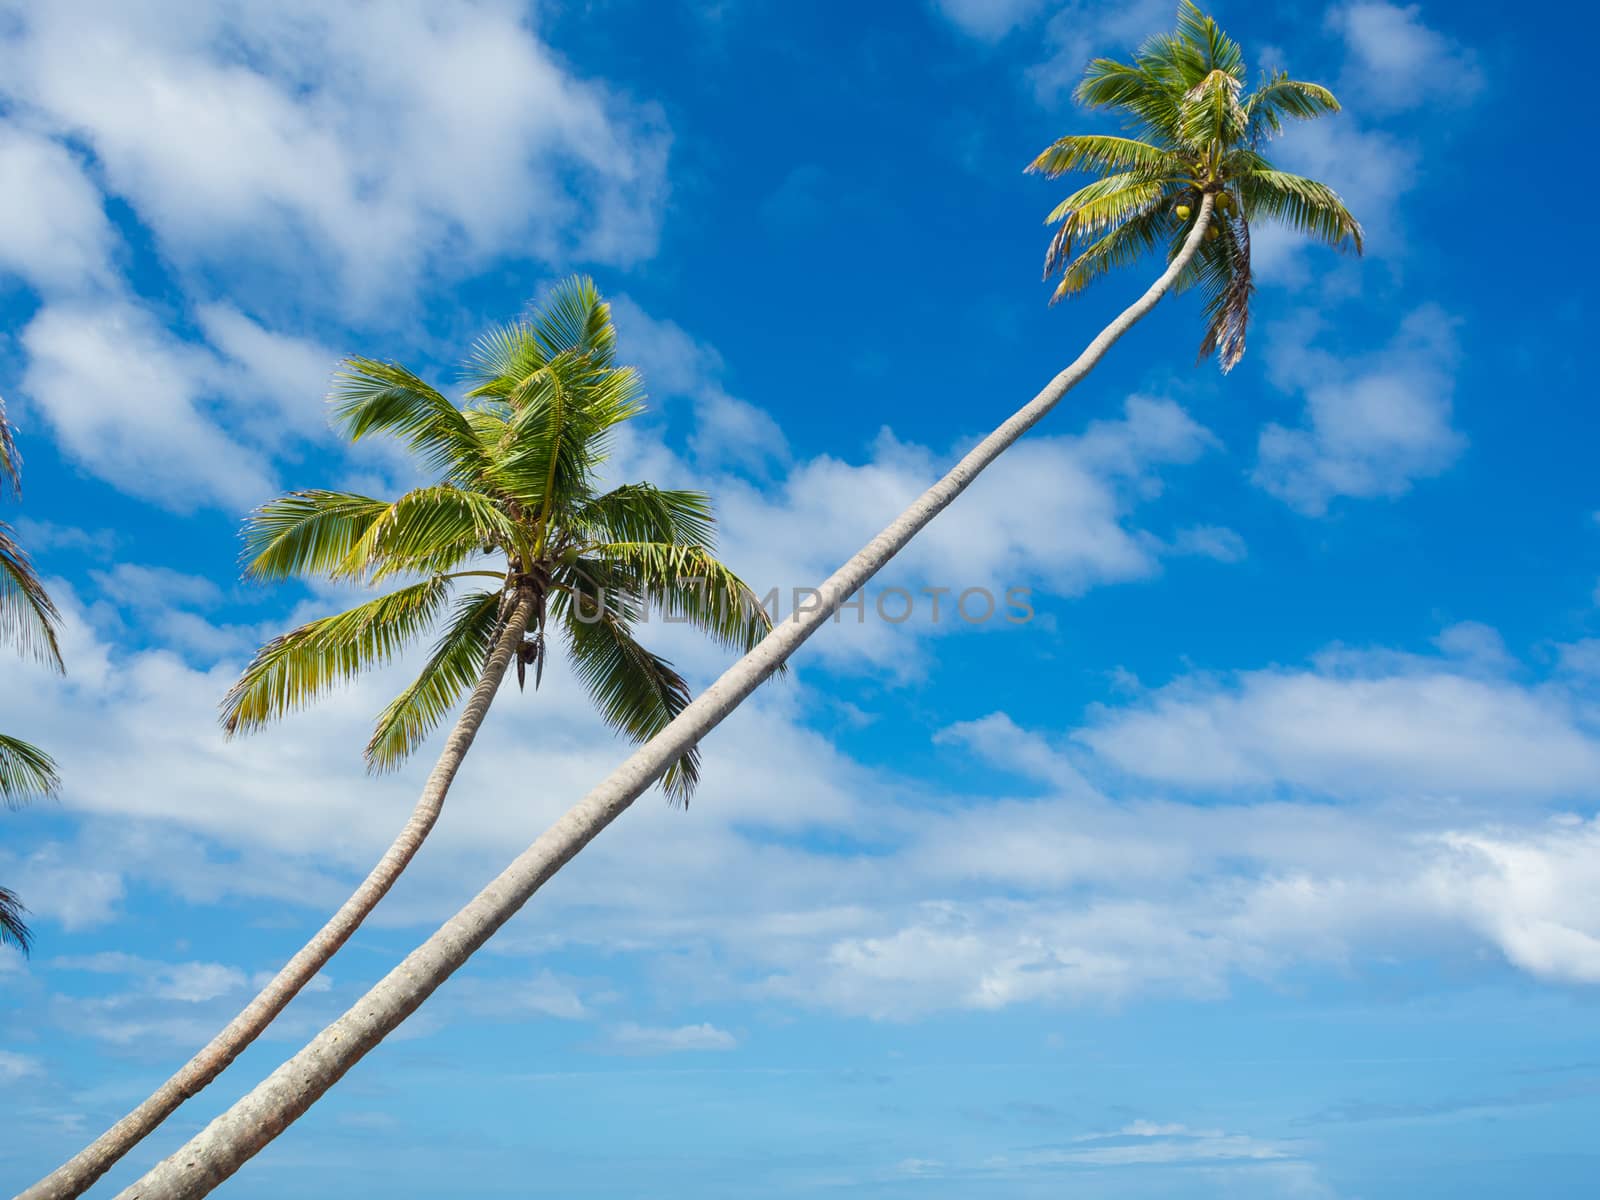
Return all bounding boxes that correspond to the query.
[0,0,669,307]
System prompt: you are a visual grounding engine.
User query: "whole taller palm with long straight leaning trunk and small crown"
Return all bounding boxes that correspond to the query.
[96,3,1358,1200]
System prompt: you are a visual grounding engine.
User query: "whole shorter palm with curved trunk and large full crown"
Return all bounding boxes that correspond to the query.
[24,278,771,1197]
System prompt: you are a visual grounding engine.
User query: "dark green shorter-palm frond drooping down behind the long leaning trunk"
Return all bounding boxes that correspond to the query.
[562,605,699,805]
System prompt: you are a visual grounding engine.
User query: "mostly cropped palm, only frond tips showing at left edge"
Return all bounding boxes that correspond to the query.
[0,400,66,954]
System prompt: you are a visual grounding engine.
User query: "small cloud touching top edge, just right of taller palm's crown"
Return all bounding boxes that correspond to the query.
[1328,0,1483,110]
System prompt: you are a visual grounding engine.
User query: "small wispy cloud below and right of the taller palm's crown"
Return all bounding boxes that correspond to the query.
[1254,304,1466,515]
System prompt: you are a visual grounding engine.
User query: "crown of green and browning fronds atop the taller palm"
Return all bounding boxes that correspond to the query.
[1027,0,1362,371]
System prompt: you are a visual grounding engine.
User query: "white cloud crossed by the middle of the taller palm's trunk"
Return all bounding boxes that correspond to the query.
[715,397,1216,678]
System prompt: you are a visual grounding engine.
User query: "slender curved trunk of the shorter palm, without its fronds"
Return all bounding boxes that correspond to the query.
[16,590,536,1200]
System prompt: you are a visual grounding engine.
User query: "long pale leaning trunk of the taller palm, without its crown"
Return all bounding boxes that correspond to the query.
[100,195,1211,1200]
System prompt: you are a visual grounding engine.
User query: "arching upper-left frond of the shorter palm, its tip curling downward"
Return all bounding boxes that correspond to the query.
[331,355,485,482]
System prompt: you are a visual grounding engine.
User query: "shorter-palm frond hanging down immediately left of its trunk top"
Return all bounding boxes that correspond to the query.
[366,590,502,771]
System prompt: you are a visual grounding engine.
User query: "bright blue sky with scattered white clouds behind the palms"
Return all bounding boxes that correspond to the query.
[0,0,1600,1200]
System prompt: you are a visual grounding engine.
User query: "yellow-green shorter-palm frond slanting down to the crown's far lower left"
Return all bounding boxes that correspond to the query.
[222,579,450,736]
